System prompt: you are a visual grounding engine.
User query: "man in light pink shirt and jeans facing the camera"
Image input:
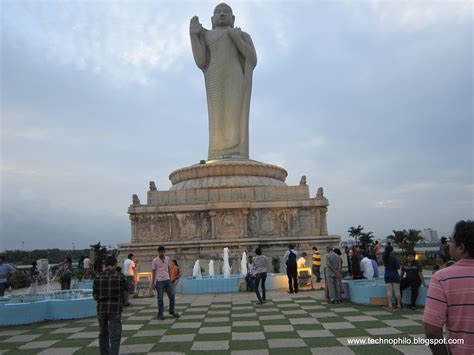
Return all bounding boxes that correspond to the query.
[151,246,179,320]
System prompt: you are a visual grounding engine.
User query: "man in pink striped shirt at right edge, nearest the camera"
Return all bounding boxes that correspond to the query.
[422,221,474,355]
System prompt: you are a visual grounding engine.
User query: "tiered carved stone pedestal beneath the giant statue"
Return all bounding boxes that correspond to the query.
[120,160,339,276]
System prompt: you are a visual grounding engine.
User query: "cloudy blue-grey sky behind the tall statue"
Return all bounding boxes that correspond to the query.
[0,0,474,250]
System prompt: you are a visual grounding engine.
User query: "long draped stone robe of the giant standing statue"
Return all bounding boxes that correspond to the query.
[203,30,256,160]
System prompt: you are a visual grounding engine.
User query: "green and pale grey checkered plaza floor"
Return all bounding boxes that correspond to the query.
[0,291,431,355]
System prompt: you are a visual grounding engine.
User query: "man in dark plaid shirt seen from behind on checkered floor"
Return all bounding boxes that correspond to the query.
[92,255,128,355]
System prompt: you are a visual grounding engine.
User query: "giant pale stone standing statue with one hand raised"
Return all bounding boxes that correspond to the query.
[189,3,257,160]
